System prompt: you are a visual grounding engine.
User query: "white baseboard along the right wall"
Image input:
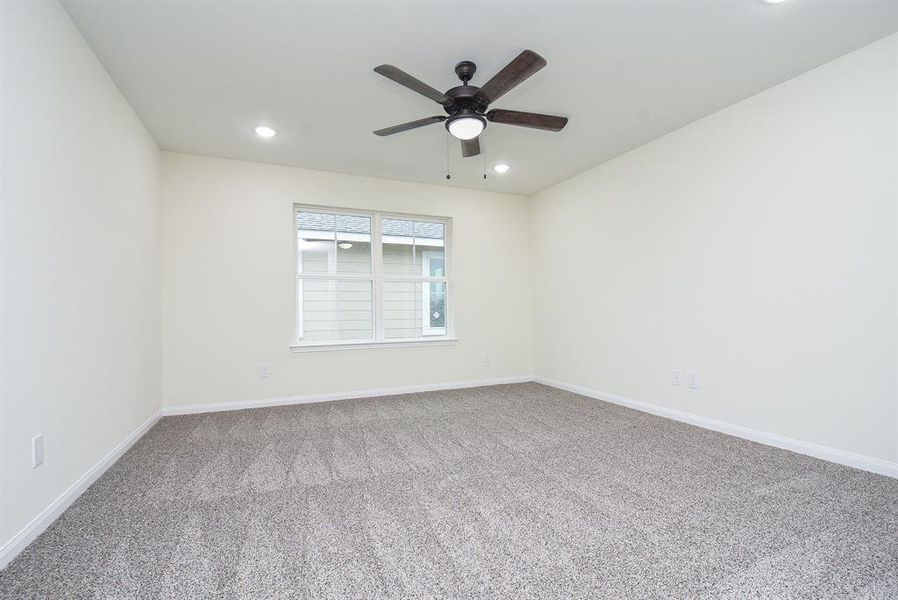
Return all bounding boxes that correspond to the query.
[534,377,898,478]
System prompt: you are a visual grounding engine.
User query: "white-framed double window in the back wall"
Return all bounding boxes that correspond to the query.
[293,206,452,350]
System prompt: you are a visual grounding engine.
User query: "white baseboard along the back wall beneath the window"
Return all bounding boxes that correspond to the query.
[162,375,533,417]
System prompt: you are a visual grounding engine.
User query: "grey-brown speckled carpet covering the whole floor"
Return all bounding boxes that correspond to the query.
[0,384,898,599]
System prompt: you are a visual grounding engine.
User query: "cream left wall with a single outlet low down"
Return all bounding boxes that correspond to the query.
[0,2,162,542]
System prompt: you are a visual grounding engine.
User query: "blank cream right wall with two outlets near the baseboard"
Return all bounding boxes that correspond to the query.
[532,36,898,461]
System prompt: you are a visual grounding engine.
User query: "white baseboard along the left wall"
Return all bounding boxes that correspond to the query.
[0,411,162,569]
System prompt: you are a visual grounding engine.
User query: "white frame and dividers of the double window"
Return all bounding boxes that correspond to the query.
[290,204,457,352]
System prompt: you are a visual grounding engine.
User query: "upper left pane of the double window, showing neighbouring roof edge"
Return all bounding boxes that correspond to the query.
[296,212,371,275]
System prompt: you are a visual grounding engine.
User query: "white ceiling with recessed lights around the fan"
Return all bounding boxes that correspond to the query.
[64,0,898,194]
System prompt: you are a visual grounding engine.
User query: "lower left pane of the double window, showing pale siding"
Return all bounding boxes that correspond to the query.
[298,279,374,342]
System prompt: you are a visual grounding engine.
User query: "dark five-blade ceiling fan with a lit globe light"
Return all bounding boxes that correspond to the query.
[374,50,567,157]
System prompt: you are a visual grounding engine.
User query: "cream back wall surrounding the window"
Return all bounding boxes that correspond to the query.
[162,152,531,406]
